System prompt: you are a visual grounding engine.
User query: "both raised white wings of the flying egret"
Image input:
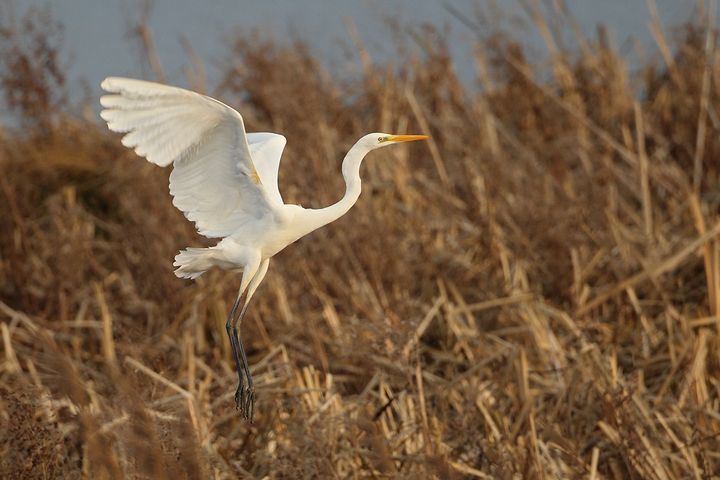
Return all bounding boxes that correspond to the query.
[100,77,285,237]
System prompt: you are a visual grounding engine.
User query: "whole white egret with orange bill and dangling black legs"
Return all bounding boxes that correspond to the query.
[100,77,428,420]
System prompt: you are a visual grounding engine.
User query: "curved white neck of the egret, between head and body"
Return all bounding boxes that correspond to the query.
[306,143,369,231]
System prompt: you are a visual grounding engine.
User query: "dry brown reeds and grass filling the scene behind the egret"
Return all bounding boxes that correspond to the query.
[0,4,720,479]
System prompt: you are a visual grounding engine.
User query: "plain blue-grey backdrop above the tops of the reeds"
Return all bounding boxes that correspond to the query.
[0,0,695,95]
